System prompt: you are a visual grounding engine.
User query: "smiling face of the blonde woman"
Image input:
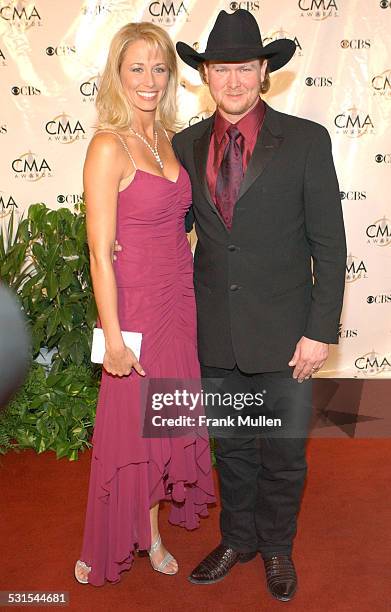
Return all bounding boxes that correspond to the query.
[120,39,169,112]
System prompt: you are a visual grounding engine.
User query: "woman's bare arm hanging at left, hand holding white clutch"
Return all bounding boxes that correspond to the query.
[83,133,143,376]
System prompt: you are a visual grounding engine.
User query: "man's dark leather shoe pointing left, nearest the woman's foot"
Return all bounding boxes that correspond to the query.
[189,544,257,584]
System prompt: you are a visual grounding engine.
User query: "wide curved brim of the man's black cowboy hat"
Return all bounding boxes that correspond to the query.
[176,38,296,72]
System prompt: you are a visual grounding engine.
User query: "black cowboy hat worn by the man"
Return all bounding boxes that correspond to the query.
[176,9,296,72]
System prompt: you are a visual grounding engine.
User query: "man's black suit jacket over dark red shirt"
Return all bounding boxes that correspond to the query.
[173,105,346,373]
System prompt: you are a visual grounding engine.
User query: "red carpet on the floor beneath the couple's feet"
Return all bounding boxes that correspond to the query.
[0,387,391,612]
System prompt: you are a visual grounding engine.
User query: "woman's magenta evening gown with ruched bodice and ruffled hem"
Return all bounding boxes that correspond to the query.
[79,148,215,586]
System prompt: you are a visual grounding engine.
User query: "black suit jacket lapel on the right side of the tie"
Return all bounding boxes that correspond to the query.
[238,104,284,200]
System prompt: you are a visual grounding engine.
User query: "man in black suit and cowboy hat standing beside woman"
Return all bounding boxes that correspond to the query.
[173,9,346,601]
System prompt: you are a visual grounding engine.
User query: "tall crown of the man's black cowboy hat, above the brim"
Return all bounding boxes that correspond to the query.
[206,9,263,51]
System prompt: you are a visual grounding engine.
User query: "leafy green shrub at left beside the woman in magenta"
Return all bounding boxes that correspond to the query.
[0,204,101,460]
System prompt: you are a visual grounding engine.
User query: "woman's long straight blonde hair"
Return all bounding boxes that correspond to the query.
[96,21,178,130]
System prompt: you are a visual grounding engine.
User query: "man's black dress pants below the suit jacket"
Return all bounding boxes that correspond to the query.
[201,365,312,559]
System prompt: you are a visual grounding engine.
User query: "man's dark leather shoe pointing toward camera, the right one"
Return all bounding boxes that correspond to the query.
[263,554,297,601]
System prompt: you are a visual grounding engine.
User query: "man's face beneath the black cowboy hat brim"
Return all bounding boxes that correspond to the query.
[205,59,267,122]
